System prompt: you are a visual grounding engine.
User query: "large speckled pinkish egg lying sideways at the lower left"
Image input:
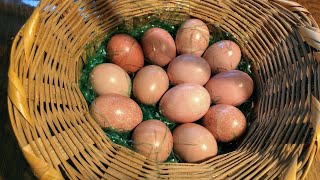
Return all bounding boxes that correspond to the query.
[90,94,142,131]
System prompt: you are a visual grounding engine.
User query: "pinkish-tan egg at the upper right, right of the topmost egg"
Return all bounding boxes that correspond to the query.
[203,40,241,73]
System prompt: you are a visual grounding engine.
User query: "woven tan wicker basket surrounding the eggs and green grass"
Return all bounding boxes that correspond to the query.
[8,0,320,179]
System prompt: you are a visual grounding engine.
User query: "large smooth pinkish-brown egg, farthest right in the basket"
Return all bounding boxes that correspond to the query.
[205,70,254,106]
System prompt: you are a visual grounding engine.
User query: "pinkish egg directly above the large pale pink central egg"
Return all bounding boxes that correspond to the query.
[167,54,211,86]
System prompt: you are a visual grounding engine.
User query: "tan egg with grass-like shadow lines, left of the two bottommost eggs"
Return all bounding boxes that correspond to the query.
[132,119,173,162]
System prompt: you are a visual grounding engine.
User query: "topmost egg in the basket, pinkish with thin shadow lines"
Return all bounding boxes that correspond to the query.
[176,19,210,56]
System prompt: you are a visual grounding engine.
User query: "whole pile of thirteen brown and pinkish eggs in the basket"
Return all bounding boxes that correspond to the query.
[90,19,254,162]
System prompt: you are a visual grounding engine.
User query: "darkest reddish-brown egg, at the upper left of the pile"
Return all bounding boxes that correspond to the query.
[107,34,144,73]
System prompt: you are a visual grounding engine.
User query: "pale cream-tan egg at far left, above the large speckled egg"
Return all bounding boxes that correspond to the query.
[90,63,131,97]
